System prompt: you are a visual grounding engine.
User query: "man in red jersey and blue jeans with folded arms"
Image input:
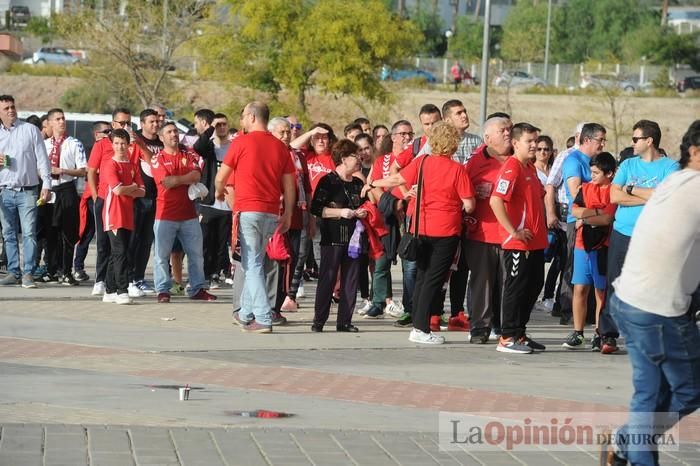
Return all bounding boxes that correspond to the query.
[151,122,216,303]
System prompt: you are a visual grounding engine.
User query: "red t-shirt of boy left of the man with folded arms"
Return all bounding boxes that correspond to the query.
[100,159,143,231]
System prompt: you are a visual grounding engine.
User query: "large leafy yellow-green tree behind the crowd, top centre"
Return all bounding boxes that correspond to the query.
[198,0,422,112]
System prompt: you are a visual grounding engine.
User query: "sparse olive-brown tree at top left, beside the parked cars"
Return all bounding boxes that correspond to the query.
[54,0,207,107]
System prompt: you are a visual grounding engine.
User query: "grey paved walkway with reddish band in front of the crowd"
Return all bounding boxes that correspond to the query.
[0,255,700,466]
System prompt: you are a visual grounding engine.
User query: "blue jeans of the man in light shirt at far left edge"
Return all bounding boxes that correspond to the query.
[0,188,38,278]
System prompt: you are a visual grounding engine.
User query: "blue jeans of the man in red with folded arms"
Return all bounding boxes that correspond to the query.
[153,218,204,296]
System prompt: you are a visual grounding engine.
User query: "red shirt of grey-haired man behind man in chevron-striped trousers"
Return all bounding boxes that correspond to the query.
[465,146,503,244]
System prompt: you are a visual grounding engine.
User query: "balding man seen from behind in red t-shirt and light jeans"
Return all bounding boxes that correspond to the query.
[216,102,296,333]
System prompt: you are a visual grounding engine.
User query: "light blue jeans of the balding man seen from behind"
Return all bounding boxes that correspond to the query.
[238,212,278,325]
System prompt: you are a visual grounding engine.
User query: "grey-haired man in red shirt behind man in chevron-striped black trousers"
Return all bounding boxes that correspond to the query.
[464,117,513,344]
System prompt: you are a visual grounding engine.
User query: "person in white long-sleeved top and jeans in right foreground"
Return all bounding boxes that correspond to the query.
[606,120,700,464]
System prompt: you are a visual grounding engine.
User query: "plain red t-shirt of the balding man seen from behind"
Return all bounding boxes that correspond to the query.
[224,131,295,215]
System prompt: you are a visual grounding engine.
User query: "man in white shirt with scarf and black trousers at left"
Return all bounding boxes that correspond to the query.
[44,108,87,286]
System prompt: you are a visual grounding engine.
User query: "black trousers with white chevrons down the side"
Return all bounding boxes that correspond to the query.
[501,250,544,339]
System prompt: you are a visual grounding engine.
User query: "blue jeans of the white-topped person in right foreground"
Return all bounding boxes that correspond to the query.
[609,294,700,465]
